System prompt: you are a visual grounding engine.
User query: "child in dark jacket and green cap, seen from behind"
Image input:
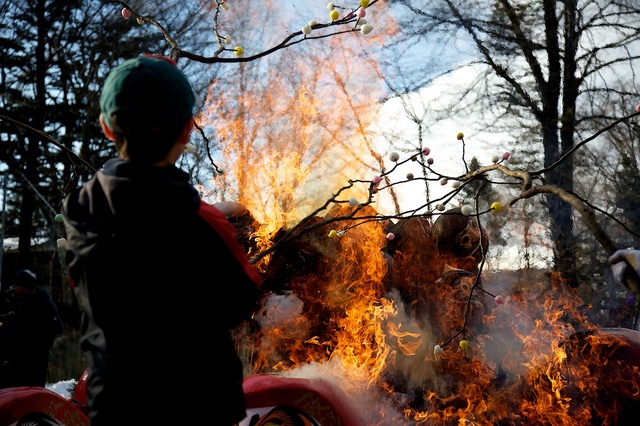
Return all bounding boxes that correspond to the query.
[63,56,262,426]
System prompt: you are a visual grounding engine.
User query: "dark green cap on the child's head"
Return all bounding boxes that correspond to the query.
[100,56,195,130]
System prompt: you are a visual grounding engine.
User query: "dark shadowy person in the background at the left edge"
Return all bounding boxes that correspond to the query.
[0,269,63,388]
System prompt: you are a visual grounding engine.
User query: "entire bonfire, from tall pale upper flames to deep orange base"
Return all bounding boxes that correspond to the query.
[192,2,640,426]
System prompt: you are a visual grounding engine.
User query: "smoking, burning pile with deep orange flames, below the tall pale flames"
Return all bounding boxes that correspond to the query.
[226,205,640,426]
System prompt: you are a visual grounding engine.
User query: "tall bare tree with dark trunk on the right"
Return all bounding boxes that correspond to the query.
[384,0,640,286]
